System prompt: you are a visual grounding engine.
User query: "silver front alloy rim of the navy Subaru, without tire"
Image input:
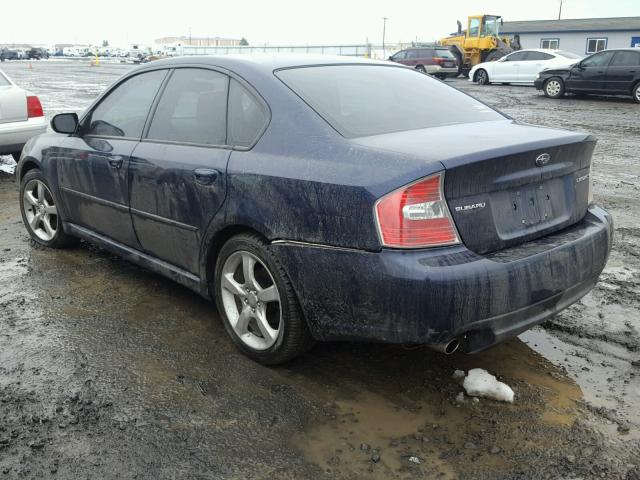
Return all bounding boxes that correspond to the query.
[22,179,58,242]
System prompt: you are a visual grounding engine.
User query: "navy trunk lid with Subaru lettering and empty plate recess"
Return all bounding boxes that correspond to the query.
[352,121,595,253]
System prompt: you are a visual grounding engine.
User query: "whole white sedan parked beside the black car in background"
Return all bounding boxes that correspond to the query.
[469,48,582,85]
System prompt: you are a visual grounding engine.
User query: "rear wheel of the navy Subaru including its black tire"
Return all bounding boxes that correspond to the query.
[213,234,313,365]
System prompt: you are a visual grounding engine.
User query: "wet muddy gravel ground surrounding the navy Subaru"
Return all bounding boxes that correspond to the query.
[0,61,640,480]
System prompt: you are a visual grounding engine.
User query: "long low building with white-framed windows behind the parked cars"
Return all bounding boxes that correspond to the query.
[500,17,640,55]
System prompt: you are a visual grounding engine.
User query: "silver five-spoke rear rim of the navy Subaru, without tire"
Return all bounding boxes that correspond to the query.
[218,250,282,350]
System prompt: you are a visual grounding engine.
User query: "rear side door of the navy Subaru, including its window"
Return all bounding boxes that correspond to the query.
[129,68,264,275]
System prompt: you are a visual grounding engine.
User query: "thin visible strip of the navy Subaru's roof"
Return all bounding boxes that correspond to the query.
[138,54,390,71]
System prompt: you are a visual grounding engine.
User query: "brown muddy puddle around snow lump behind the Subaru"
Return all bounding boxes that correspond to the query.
[296,339,582,479]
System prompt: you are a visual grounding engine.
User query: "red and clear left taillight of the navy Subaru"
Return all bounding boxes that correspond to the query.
[375,172,460,248]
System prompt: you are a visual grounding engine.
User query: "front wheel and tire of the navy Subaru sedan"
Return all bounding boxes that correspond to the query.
[20,169,78,248]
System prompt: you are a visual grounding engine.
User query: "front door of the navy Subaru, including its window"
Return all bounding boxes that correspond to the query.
[58,70,167,248]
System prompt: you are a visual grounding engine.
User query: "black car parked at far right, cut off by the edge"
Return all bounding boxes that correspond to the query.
[534,48,640,103]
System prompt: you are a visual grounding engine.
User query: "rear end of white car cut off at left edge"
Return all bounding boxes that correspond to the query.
[0,71,47,161]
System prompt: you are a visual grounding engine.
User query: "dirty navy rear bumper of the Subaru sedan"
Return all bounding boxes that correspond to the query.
[272,206,613,352]
